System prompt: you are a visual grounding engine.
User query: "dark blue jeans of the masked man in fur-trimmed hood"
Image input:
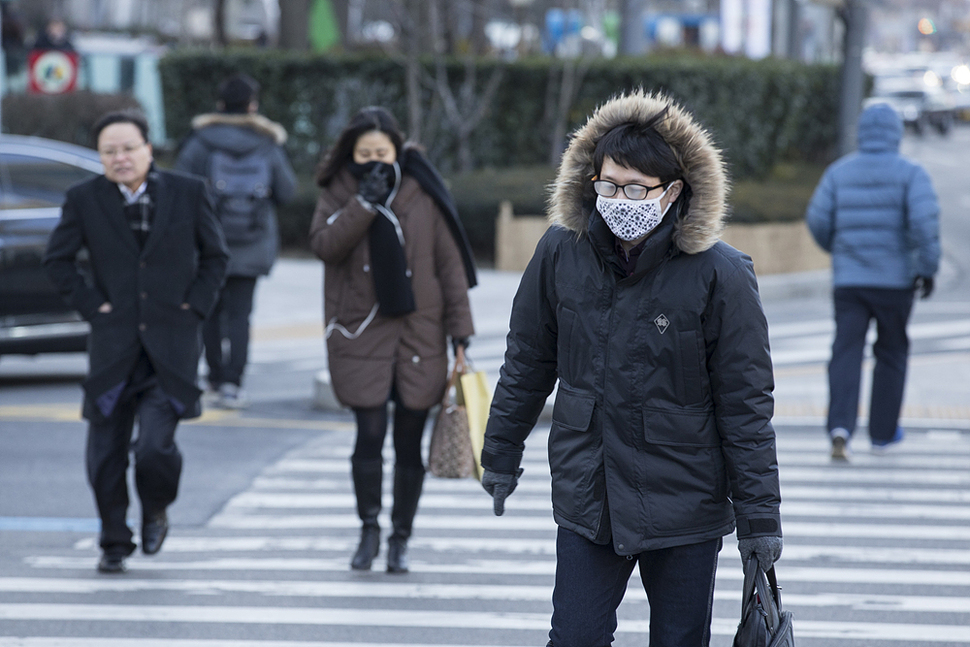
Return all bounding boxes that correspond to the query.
[547,528,721,647]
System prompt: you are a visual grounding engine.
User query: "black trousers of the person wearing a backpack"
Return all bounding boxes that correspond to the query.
[202,276,256,389]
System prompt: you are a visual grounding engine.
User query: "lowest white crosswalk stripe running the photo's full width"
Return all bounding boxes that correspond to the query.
[0,604,970,645]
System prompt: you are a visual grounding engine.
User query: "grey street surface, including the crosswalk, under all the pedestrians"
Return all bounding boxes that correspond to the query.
[0,128,970,647]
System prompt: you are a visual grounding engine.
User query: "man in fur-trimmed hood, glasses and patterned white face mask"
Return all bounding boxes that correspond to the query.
[482,91,782,647]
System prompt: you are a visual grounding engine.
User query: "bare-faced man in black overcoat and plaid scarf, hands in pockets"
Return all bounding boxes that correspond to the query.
[44,112,228,573]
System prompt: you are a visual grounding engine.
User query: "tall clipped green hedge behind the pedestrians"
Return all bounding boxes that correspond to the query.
[161,50,838,179]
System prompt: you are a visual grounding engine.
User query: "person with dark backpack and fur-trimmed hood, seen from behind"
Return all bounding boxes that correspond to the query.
[175,74,296,409]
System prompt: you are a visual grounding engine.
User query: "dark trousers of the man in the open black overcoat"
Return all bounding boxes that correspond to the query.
[87,353,182,555]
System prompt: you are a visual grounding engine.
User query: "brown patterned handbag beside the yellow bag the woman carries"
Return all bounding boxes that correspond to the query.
[428,349,477,479]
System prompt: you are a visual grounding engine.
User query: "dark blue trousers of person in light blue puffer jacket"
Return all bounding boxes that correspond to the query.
[828,287,913,442]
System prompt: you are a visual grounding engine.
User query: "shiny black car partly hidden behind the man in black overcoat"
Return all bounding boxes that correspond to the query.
[0,135,102,355]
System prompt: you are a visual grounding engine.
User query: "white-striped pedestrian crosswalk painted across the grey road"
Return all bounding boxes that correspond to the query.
[7,430,970,647]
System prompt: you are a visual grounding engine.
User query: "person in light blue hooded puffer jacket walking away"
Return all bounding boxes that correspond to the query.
[805,103,940,461]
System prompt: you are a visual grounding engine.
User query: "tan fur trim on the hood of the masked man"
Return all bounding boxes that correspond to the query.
[548,90,728,254]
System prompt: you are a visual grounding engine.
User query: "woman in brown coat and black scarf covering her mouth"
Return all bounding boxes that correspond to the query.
[310,107,475,573]
